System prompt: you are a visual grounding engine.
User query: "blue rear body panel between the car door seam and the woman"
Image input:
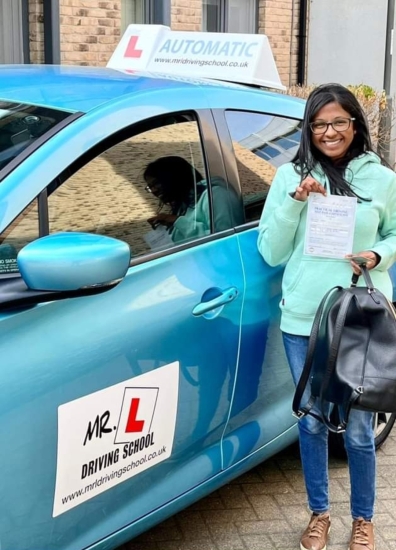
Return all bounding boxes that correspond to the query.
[223,229,295,468]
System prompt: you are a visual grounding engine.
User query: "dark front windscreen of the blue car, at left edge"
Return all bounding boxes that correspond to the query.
[0,101,70,170]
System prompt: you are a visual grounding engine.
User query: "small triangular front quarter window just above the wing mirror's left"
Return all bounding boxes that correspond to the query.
[0,199,39,275]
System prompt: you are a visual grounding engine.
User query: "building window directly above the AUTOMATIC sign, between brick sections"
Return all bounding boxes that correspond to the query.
[202,0,257,33]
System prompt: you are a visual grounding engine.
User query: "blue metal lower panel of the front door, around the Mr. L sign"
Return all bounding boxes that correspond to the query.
[0,238,244,550]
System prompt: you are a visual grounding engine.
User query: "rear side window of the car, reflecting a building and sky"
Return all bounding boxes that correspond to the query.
[225,111,301,222]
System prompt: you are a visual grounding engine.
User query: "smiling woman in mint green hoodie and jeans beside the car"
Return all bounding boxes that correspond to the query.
[258,84,396,550]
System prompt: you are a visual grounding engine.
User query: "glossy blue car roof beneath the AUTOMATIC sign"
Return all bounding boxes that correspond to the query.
[0,65,300,113]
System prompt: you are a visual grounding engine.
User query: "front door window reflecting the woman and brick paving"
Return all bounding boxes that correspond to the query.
[48,117,210,257]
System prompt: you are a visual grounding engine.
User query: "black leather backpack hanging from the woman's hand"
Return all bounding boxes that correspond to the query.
[293,265,396,433]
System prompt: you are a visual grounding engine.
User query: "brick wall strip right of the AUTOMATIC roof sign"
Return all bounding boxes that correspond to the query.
[259,0,300,86]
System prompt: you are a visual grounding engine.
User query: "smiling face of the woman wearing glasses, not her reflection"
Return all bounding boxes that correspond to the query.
[310,102,356,160]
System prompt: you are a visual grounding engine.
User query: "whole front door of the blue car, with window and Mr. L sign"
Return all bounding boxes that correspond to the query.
[0,105,245,550]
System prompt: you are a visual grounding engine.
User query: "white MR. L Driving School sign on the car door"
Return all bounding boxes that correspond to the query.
[53,362,179,517]
